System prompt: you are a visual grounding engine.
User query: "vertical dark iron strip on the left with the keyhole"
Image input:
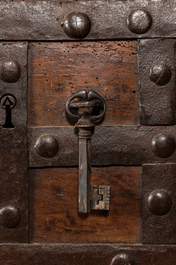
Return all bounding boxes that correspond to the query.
[0,42,28,243]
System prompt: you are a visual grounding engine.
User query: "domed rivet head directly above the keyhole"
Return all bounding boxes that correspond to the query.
[0,60,21,83]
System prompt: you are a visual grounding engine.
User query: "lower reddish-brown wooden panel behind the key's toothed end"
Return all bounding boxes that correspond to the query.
[29,167,141,243]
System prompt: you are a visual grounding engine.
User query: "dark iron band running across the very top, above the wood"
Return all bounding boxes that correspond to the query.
[0,0,176,40]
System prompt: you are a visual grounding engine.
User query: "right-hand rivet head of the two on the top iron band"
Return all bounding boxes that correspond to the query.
[127,9,152,34]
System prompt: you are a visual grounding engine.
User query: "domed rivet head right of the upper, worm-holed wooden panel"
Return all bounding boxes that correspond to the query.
[150,63,172,86]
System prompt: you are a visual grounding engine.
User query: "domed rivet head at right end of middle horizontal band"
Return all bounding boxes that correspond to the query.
[152,133,175,158]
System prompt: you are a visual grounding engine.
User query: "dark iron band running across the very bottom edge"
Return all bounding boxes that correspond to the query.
[0,244,176,265]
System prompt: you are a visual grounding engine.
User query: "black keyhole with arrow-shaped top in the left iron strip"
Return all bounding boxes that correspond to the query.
[1,94,16,128]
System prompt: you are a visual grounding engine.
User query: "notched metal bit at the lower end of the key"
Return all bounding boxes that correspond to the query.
[90,185,111,210]
